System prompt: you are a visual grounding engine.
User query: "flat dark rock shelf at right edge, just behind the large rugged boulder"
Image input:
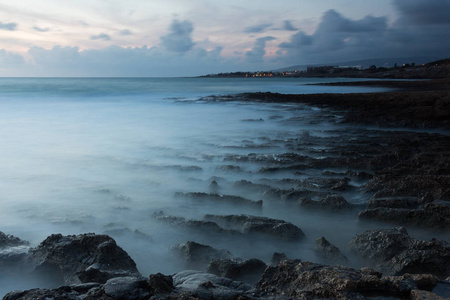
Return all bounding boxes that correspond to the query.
[358,203,450,231]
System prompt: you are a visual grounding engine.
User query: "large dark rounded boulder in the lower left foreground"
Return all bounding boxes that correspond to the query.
[29,233,140,284]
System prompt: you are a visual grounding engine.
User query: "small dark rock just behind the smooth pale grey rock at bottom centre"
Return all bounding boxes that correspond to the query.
[208,258,267,284]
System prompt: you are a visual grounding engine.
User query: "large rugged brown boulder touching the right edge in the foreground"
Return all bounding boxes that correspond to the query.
[350,227,450,278]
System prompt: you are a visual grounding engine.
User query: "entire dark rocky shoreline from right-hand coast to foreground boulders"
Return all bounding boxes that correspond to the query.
[0,80,450,300]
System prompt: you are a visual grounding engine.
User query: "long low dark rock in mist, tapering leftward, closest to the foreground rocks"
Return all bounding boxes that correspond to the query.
[204,215,305,241]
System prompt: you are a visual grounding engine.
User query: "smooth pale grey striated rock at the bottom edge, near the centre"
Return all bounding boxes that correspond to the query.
[173,270,252,300]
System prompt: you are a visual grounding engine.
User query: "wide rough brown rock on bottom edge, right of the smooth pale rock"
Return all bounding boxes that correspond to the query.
[256,260,438,299]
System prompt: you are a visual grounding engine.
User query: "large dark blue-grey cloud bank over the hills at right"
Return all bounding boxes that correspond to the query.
[278,4,450,64]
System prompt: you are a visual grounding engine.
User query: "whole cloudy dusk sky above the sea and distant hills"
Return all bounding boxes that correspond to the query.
[0,0,450,77]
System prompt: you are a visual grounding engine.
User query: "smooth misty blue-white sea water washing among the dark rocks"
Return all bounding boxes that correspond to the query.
[0,78,432,295]
